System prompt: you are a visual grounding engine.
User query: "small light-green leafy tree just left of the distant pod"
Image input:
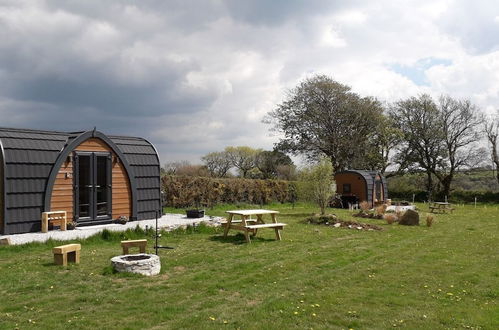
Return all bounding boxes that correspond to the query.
[300,157,335,215]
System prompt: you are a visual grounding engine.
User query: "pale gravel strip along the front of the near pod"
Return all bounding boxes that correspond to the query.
[0,213,223,245]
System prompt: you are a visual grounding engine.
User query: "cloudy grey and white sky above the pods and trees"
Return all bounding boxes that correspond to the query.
[0,0,499,164]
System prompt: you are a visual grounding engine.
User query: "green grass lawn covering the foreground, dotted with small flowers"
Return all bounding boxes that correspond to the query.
[0,204,499,329]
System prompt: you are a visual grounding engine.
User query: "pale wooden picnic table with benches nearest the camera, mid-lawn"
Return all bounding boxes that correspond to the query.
[224,210,286,243]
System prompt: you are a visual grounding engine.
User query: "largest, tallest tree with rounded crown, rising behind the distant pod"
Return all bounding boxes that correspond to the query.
[264,75,383,170]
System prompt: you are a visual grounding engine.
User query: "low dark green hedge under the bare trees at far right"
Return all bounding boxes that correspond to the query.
[388,190,499,203]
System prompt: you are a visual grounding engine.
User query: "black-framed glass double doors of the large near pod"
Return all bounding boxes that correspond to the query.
[74,152,112,223]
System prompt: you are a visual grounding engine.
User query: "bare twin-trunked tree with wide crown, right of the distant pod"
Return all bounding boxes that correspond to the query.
[391,94,483,199]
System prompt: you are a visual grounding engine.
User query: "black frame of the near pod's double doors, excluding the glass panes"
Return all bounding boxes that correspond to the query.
[73,151,113,225]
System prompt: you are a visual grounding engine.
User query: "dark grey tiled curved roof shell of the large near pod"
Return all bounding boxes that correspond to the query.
[0,128,161,234]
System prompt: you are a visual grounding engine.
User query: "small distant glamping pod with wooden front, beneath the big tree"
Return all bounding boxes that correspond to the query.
[334,170,388,207]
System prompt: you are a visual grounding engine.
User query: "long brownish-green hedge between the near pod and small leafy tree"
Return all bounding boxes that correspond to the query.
[161,175,296,207]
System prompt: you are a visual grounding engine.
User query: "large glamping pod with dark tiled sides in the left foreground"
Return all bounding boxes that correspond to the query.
[0,128,161,235]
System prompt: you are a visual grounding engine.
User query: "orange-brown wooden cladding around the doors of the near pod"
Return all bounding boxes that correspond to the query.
[50,138,132,222]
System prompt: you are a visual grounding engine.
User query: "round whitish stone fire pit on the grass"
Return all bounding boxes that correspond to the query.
[111,253,161,276]
